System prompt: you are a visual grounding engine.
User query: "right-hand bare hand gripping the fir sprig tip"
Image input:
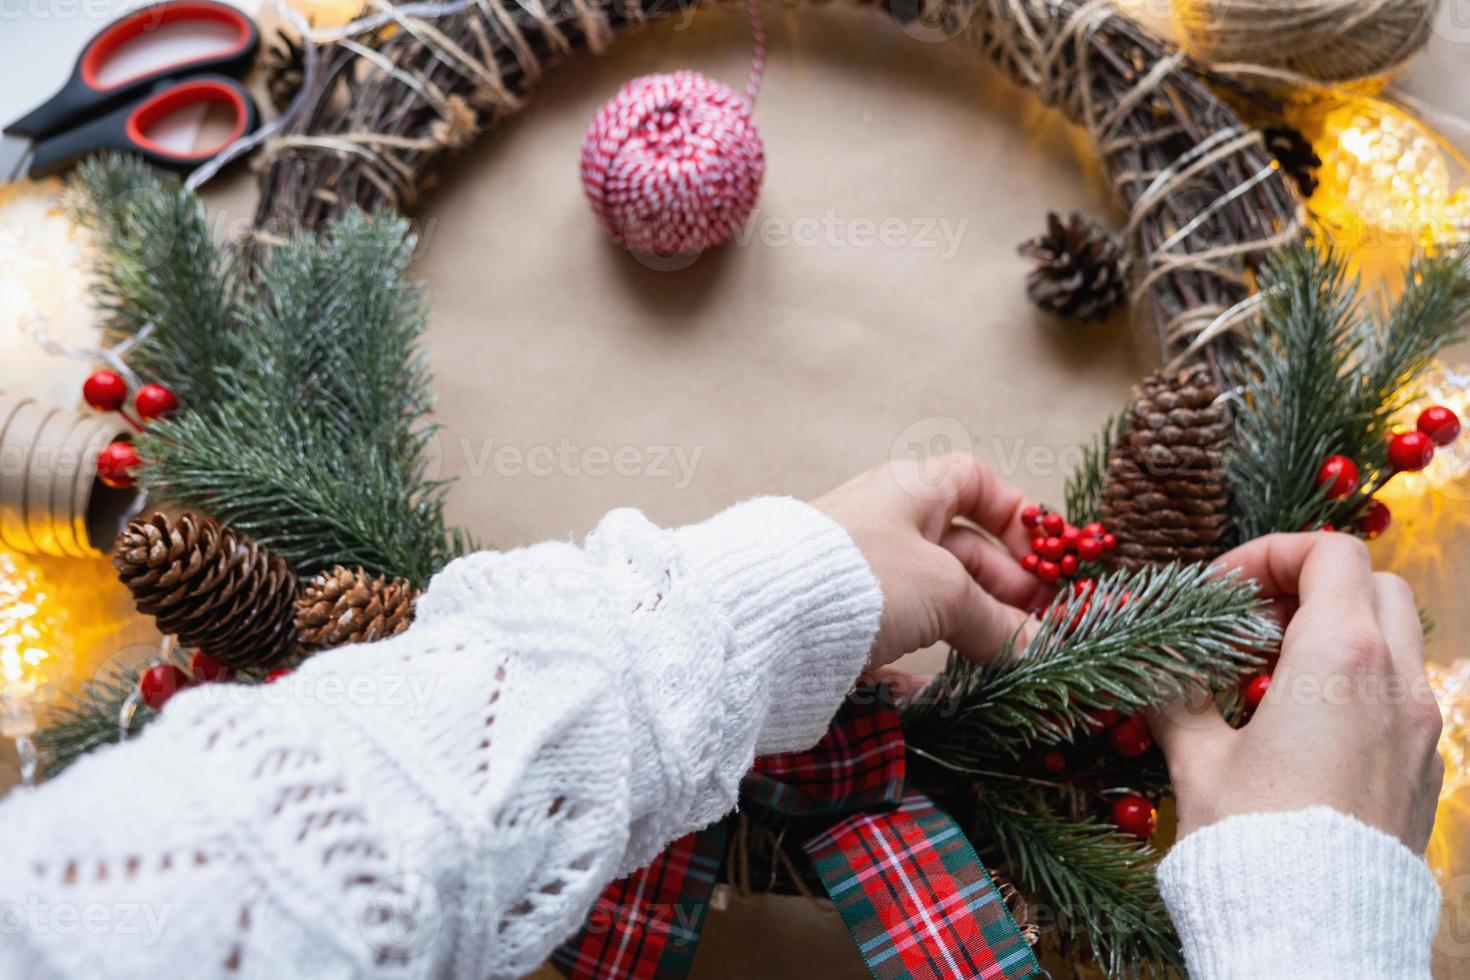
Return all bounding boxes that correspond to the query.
[1150,532,1445,852]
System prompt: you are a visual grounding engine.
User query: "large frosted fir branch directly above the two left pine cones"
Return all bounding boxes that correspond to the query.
[141,213,466,585]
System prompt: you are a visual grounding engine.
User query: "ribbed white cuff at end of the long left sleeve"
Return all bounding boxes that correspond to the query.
[675,497,883,754]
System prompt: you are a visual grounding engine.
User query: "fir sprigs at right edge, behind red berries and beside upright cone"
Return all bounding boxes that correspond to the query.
[1227,247,1470,542]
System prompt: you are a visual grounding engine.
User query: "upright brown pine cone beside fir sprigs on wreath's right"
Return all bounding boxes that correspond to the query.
[1103,367,1230,569]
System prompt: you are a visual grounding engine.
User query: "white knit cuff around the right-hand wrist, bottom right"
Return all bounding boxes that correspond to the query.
[1158,807,1439,980]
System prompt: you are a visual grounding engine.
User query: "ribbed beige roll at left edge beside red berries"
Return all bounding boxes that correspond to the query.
[0,392,140,558]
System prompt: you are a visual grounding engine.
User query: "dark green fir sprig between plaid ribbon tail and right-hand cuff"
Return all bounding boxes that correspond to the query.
[976,790,1183,977]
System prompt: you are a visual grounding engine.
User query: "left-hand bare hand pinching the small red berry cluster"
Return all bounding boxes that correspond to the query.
[811,454,1050,693]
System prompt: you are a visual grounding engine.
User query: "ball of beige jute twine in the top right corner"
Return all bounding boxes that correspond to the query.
[1175,0,1439,82]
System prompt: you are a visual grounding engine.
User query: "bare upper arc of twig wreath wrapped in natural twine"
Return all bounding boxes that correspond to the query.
[256,0,1301,365]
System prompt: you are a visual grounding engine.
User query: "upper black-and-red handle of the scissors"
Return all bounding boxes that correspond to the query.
[4,0,260,141]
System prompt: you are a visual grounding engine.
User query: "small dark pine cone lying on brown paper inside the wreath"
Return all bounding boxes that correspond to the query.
[1020,212,1127,320]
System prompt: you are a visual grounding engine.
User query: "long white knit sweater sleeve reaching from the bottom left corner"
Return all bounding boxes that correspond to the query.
[0,498,882,980]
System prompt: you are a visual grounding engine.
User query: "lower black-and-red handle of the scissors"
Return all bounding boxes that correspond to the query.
[29,75,260,176]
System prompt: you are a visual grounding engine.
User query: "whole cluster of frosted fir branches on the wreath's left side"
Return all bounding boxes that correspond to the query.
[72,157,467,585]
